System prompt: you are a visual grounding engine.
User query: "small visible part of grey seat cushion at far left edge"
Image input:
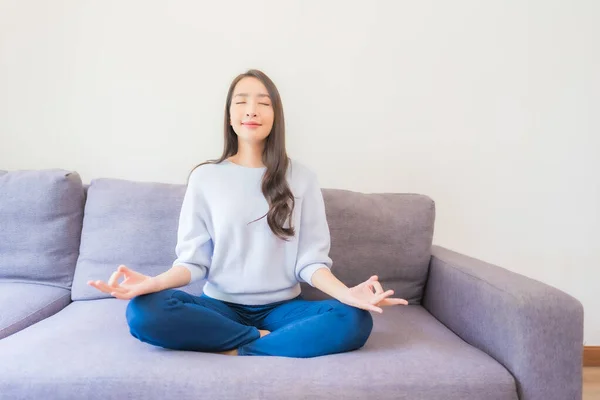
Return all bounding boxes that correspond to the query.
[0,282,71,339]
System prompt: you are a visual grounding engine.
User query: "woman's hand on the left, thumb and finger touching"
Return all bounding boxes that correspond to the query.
[87,265,160,300]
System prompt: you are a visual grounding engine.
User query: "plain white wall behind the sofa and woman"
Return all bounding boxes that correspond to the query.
[0,0,600,345]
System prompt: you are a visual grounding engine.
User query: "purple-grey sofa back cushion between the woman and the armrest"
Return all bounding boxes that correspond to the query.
[314,189,435,304]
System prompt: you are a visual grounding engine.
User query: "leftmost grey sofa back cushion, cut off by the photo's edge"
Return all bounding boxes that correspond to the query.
[0,169,84,289]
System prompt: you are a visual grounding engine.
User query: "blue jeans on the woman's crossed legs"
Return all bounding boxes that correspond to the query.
[126,289,373,358]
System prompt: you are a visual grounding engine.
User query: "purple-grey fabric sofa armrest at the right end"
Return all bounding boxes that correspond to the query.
[423,246,583,400]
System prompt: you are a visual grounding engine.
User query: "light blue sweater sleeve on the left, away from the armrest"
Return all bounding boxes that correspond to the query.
[173,174,212,282]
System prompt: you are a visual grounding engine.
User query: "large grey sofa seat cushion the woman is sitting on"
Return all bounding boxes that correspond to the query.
[0,299,517,400]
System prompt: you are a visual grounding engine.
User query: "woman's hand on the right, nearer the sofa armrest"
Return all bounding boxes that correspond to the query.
[338,275,408,314]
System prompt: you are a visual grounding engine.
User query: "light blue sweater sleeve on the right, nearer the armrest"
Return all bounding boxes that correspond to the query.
[296,174,332,286]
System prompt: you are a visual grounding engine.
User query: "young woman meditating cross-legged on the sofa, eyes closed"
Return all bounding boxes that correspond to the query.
[88,70,408,357]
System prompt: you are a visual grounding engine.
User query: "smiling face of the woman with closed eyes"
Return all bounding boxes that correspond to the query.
[229,77,274,143]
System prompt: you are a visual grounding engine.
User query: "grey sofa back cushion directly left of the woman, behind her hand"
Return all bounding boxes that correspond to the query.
[71,179,203,300]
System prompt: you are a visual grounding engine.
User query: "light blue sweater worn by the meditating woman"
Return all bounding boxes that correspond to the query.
[173,160,332,305]
